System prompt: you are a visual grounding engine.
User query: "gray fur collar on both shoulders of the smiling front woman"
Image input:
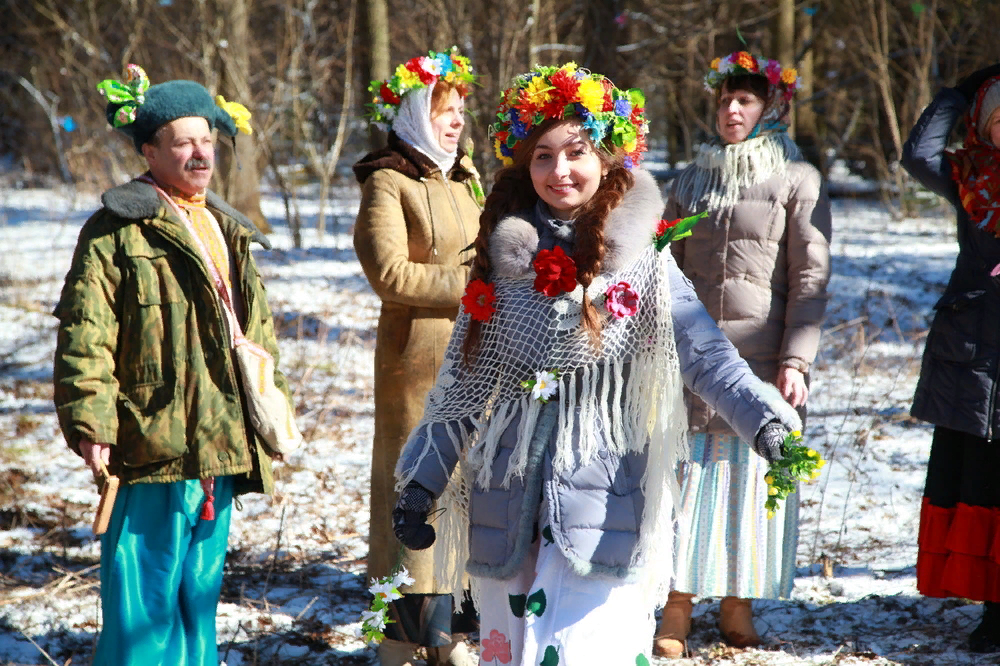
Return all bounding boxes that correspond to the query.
[489,169,663,278]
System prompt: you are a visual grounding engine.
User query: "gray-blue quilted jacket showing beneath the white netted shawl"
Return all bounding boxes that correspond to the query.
[397,172,798,580]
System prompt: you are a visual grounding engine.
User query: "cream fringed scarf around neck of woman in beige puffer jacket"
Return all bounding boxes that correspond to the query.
[673,130,802,213]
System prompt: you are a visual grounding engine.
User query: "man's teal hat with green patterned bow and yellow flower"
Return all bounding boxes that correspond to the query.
[97,65,249,153]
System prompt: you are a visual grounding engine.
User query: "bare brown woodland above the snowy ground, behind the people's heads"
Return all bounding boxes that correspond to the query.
[0,0,1000,229]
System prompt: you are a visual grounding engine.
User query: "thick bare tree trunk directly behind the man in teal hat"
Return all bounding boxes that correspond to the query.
[215,0,271,233]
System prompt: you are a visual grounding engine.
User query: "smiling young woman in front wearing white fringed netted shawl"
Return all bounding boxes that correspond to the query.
[393,63,799,666]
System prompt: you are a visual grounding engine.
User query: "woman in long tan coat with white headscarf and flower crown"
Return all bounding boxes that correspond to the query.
[354,51,482,666]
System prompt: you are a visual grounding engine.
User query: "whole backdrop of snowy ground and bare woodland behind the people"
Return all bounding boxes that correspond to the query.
[0,0,1000,666]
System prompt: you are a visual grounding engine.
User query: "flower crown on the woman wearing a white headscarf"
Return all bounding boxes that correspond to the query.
[366,46,476,131]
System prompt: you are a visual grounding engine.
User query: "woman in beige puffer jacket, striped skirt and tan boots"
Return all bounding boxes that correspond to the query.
[655,51,830,656]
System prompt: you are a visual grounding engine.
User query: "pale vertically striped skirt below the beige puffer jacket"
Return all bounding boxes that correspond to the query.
[674,433,799,599]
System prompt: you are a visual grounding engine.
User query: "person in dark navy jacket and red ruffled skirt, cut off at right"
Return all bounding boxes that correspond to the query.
[902,64,1000,652]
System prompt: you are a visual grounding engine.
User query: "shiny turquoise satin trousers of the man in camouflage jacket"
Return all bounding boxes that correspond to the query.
[93,476,233,666]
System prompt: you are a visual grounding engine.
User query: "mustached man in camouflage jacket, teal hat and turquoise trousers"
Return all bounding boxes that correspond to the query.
[54,65,288,666]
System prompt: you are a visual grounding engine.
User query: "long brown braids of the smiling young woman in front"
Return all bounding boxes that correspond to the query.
[462,119,635,364]
